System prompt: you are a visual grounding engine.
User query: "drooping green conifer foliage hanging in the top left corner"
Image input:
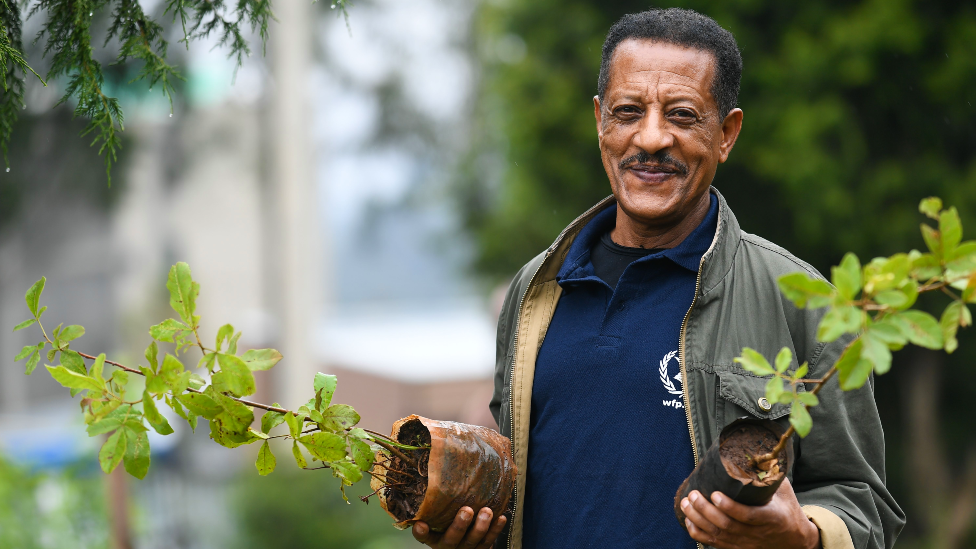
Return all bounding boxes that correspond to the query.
[0,0,348,185]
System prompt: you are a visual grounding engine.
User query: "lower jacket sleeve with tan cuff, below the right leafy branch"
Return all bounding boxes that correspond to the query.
[793,337,905,549]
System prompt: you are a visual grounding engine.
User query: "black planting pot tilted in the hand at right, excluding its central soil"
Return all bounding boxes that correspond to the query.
[674,417,793,527]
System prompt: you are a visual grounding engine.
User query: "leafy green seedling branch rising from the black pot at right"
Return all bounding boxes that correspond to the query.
[735,197,976,471]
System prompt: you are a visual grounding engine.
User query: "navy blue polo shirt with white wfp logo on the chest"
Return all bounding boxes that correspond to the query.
[523,197,718,549]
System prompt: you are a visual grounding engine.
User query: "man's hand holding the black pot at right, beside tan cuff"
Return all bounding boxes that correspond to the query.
[681,479,820,549]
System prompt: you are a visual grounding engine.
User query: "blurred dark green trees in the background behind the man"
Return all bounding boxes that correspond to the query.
[459,0,976,547]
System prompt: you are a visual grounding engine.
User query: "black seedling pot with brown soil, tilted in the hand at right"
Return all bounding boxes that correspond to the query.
[674,418,793,527]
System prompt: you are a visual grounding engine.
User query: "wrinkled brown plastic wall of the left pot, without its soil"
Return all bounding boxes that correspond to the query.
[370,415,516,531]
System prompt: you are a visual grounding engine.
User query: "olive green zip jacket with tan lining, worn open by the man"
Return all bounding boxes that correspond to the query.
[490,188,905,549]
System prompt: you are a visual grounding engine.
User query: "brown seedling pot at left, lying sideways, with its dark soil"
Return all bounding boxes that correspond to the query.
[370,416,515,531]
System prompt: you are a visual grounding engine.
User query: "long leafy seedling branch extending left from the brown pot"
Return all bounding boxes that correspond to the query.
[14,263,424,497]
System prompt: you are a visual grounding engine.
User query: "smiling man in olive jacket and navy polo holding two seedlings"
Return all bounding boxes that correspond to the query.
[414,9,904,549]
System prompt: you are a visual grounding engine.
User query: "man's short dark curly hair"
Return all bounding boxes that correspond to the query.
[597,8,742,118]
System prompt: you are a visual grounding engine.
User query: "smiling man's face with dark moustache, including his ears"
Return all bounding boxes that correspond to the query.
[593,39,742,227]
